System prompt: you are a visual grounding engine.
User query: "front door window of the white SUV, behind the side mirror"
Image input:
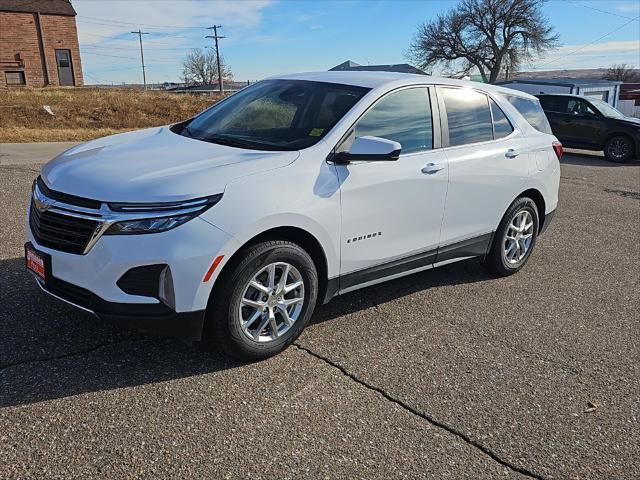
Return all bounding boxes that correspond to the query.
[355,88,433,153]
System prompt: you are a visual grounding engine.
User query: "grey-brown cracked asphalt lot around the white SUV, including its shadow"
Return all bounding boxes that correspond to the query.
[0,146,640,479]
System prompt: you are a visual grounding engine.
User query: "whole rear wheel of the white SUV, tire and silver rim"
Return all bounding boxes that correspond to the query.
[483,197,540,277]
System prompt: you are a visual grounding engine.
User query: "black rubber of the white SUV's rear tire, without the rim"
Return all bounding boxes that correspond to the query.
[483,197,540,277]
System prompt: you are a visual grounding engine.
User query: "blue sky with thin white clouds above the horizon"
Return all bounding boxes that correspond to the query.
[72,0,640,83]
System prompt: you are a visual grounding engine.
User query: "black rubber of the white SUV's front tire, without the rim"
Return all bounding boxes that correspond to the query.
[203,240,318,361]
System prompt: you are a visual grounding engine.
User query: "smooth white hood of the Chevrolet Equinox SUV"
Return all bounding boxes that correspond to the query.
[42,127,299,202]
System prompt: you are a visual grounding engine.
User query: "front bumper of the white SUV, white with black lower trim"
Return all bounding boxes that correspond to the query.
[26,208,237,341]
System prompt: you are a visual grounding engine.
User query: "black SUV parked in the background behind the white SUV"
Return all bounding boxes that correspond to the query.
[537,94,640,162]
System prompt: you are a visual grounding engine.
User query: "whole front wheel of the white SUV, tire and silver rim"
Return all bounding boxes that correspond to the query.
[203,240,318,361]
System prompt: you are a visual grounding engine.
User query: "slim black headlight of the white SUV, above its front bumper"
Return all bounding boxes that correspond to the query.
[104,194,222,235]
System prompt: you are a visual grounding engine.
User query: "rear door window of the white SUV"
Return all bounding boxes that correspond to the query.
[439,88,493,147]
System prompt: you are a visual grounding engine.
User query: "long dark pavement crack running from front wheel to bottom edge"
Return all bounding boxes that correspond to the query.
[292,343,546,480]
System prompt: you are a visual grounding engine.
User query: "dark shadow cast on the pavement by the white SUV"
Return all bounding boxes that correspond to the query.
[0,258,491,407]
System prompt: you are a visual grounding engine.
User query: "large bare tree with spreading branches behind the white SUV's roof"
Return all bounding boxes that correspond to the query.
[407,0,559,83]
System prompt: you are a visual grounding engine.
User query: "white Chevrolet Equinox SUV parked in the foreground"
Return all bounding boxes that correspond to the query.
[25,72,562,359]
